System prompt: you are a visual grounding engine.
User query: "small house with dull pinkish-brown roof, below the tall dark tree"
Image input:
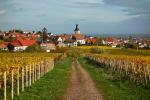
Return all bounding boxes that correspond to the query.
[40,43,56,52]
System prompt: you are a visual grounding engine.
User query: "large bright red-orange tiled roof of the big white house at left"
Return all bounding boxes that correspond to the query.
[10,37,36,46]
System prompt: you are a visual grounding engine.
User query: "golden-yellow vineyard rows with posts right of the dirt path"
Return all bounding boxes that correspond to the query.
[86,53,150,85]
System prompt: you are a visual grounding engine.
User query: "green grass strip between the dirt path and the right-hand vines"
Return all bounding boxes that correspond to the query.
[79,57,150,100]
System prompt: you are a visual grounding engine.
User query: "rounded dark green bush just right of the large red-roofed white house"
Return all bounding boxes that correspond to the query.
[25,44,45,52]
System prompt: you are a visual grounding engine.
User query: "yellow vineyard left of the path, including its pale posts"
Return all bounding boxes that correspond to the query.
[0,53,61,100]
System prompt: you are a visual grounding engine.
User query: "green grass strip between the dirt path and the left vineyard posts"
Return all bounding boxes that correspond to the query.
[15,58,71,100]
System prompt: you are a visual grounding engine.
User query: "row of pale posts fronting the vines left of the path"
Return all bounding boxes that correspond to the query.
[0,59,54,100]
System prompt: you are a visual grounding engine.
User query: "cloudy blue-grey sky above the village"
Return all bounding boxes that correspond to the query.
[0,0,150,34]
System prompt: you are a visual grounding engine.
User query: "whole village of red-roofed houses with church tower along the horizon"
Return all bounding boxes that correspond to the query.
[0,25,150,52]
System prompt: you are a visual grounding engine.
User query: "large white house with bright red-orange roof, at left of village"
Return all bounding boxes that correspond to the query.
[7,37,36,51]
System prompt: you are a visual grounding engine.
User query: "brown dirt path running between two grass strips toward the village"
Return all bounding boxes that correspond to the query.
[64,62,102,100]
